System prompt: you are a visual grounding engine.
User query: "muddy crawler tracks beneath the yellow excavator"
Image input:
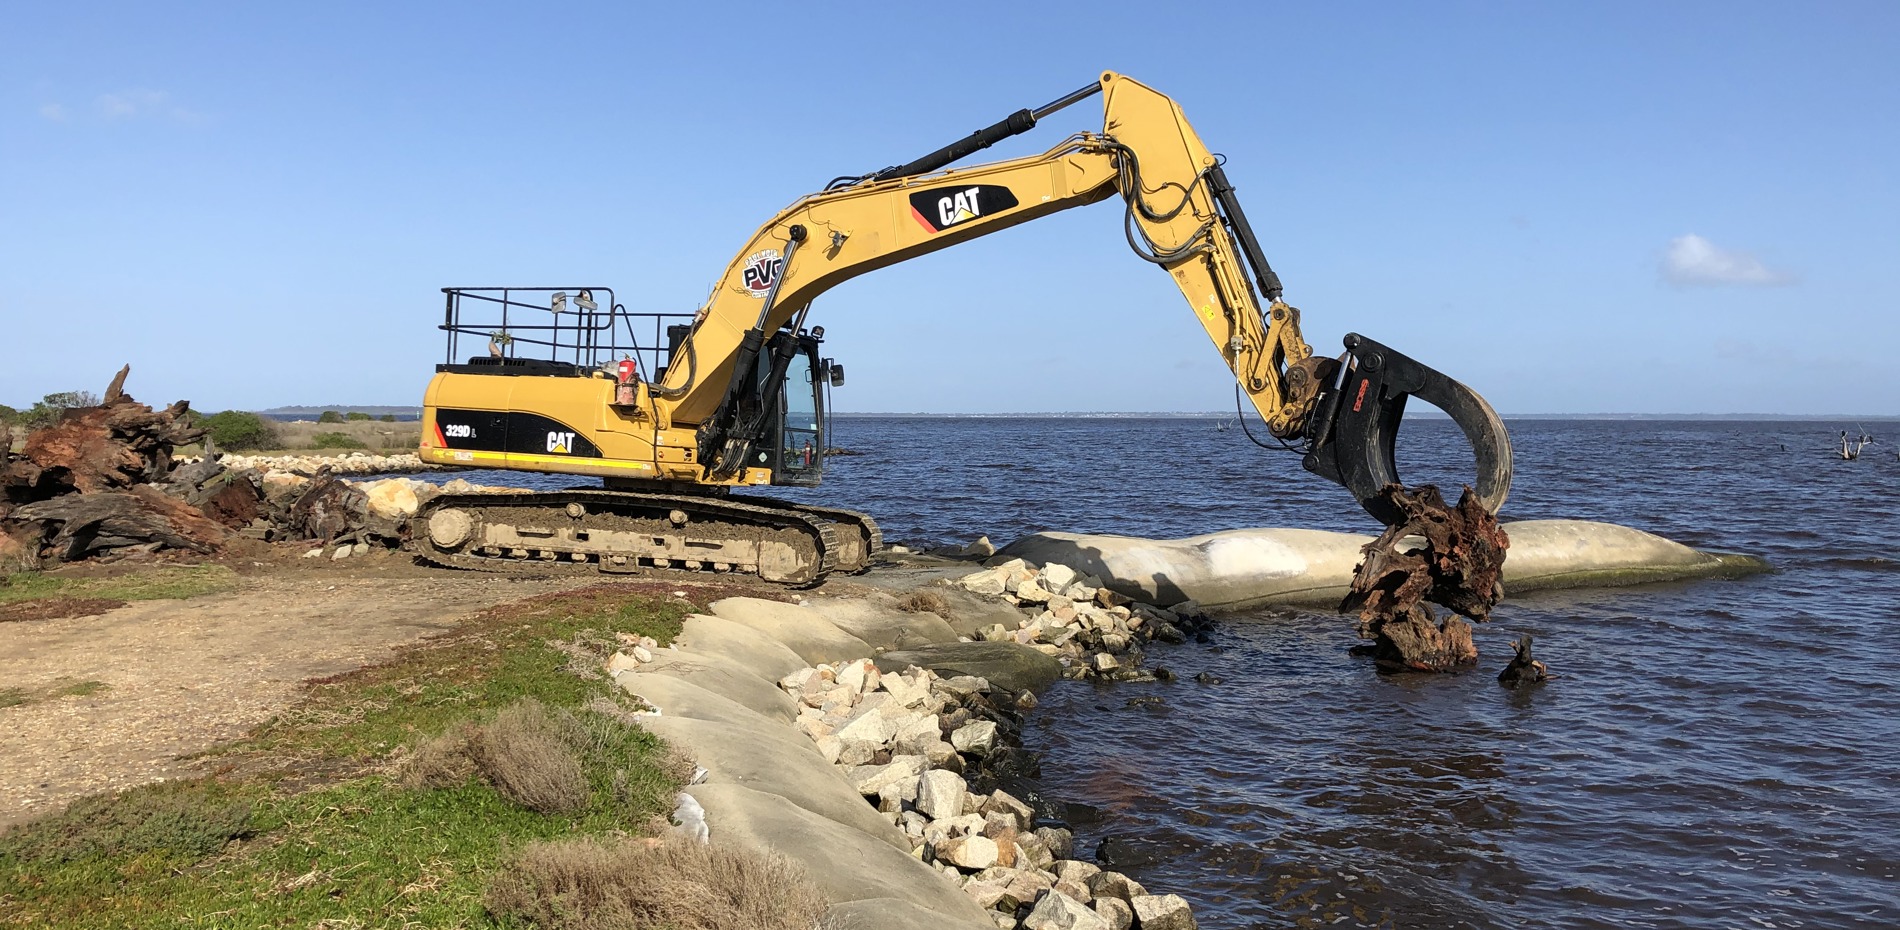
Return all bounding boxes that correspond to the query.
[409,489,880,586]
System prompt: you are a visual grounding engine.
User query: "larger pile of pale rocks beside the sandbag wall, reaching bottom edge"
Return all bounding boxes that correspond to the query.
[779,660,1195,930]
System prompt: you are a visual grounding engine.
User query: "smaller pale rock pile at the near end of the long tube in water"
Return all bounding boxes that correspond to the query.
[958,559,1207,681]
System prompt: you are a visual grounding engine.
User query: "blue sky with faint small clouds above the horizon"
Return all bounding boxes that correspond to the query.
[0,2,1900,415]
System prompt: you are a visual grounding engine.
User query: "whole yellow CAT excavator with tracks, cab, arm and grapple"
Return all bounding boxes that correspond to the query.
[410,72,1511,584]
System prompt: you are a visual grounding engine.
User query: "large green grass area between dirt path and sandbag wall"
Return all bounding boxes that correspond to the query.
[0,586,692,928]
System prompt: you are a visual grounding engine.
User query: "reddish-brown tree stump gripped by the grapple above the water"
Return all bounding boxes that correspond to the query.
[1340,485,1511,671]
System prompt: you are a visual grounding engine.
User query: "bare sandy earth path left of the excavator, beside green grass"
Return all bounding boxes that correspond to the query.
[0,553,589,827]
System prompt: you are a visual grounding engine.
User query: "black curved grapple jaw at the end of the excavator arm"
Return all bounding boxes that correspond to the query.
[1303,333,1511,527]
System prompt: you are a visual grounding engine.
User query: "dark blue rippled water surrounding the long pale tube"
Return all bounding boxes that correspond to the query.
[419,418,1900,928]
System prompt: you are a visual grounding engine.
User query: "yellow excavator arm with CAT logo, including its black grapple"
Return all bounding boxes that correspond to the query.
[661,72,1511,523]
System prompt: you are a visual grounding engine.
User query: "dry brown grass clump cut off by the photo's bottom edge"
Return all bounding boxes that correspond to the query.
[485,837,825,930]
